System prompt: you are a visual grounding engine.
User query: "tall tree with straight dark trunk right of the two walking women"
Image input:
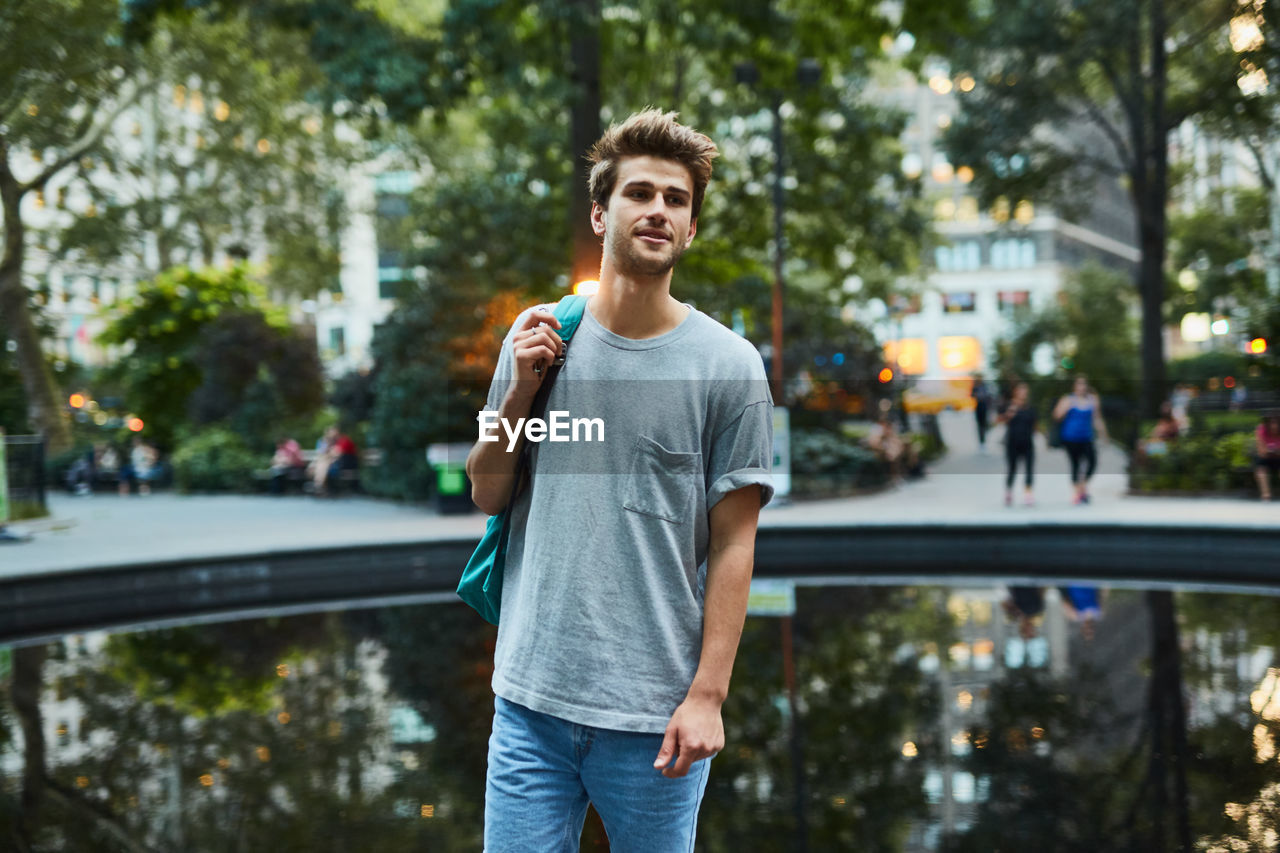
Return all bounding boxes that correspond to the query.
[904,0,1269,416]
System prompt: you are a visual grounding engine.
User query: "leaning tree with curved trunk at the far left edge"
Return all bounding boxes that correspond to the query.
[0,0,142,452]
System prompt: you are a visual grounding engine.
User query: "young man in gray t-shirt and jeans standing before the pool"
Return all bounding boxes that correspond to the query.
[467,110,773,853]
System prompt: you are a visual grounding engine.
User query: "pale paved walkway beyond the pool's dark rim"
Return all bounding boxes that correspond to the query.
[0,412,1280,578]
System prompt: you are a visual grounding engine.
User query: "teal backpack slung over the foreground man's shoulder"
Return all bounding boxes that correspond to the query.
[458,296,586,625]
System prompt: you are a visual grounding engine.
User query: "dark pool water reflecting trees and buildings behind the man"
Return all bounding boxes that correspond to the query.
[0,585,1280,852]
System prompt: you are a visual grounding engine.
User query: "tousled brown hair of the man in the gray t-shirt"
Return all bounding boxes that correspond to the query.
[586,108,719,219]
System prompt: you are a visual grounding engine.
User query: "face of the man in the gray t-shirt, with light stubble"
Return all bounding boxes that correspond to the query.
[591,155,698,275]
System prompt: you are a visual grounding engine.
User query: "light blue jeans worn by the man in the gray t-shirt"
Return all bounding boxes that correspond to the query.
[484,697,710,853]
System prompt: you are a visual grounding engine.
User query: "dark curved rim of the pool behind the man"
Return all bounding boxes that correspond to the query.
[0,523,1280,644]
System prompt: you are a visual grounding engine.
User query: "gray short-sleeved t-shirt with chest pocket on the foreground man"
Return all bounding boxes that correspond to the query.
[486,300,773,733]
